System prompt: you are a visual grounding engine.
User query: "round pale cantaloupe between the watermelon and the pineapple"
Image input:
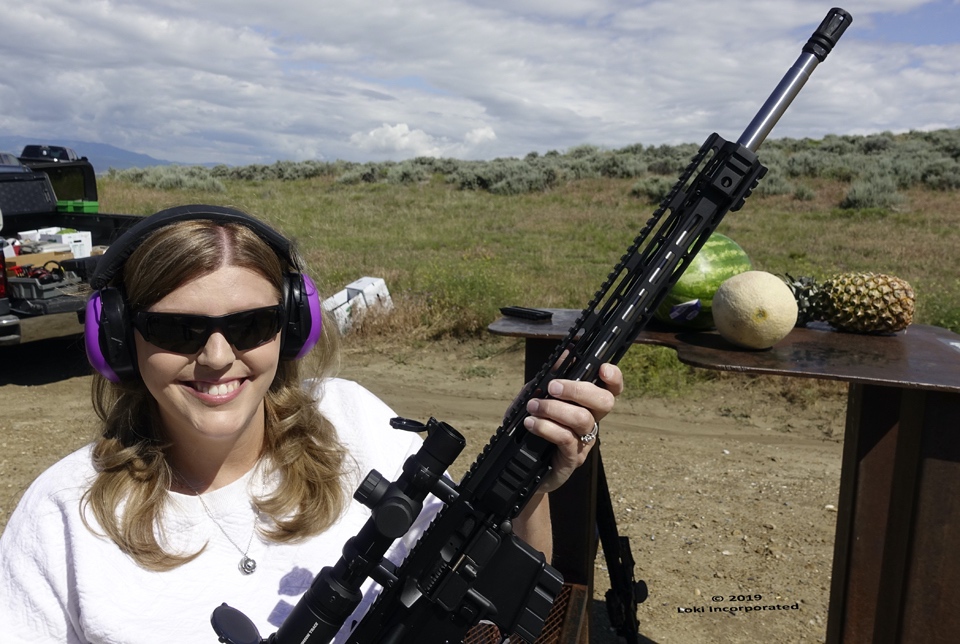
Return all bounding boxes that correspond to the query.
[713,271,797,349]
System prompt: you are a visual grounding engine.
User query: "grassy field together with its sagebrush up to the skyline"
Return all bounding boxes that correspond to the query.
[101,137,960,358]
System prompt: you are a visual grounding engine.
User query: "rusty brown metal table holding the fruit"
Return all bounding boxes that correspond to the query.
[489,309,960,644]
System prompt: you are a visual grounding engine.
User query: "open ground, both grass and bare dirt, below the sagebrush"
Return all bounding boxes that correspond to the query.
[0,133,960,643]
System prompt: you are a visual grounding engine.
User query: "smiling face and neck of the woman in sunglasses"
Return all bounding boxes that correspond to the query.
[135,266,284,496]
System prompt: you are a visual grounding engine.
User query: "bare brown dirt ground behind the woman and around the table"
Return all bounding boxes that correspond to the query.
[0,316,845,644]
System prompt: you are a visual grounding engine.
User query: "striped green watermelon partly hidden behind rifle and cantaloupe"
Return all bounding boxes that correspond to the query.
[654,233,753,331]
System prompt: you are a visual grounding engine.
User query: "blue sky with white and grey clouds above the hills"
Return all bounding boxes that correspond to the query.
[0,0,960,165]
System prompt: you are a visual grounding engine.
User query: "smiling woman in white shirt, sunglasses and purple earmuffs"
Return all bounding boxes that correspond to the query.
[0,206,622,643]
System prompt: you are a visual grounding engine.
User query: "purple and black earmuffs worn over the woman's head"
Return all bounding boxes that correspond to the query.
[83,205,322,382]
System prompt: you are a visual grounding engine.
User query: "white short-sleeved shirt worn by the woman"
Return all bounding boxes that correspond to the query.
[0,379,440,644]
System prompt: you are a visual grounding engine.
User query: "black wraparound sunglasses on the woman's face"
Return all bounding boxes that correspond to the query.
[133,304,283,354]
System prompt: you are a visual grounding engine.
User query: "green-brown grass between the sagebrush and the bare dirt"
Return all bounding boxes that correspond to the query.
[100,165,960,394]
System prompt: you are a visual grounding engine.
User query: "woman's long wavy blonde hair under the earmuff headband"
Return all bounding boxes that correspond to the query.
[83,220,347,570]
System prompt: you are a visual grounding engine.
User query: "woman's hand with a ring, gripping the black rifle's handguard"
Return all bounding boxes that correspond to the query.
[524,364,623,492]
